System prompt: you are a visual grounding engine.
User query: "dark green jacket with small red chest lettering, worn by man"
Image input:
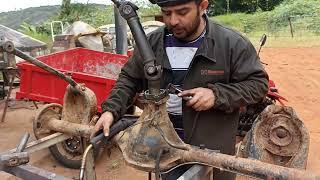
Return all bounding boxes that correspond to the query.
[102,16,268,154]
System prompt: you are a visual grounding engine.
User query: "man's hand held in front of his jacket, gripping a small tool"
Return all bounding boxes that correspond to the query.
[178,88,215,111]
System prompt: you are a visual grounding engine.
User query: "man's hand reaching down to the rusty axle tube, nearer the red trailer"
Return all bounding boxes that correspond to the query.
[91,111,113,137]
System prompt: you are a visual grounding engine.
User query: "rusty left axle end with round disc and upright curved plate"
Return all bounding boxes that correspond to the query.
[34,84,97,138]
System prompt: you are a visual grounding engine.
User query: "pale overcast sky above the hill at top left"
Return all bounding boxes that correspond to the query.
[0,0,111,12]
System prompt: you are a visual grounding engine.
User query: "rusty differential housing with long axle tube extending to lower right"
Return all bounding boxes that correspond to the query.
[115,96,318,179]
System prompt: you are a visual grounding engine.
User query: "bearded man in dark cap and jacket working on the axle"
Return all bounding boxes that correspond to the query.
[95,0,268,179]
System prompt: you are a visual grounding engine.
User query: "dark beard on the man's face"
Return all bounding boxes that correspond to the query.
[167,9,202,41]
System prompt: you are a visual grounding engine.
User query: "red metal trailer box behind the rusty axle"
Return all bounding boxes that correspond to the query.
[16,48,128,112]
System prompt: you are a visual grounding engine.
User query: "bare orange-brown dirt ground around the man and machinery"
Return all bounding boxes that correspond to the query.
[0,48,320,180]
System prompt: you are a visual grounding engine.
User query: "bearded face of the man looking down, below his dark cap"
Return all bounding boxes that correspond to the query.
[161,1,202,40]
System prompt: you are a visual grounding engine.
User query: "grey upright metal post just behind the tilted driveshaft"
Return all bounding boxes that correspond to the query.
[114,5,128,55]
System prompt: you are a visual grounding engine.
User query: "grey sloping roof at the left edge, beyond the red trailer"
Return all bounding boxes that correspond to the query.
[0,24,48,51]
